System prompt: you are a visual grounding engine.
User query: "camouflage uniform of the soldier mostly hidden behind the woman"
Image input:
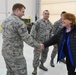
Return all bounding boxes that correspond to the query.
[51,19,62,59]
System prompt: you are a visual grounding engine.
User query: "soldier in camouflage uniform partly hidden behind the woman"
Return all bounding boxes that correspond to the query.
[50,11,66,67]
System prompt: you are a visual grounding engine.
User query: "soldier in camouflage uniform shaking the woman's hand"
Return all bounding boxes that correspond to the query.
[2,3,39,75]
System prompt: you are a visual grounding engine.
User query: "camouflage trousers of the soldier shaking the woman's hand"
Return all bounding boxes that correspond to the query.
[5,58,27,75]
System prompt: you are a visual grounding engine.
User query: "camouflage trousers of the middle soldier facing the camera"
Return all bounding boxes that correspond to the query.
[33,48,49,68]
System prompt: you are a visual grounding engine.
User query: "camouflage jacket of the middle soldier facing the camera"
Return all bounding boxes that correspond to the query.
[30,19,52,43]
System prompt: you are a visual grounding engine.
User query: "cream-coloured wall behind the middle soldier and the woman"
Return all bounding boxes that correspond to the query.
[40,0,76,23]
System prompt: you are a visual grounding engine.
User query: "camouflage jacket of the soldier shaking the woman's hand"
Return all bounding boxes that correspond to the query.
[2,14,39,59]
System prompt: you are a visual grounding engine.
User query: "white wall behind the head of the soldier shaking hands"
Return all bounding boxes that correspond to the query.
[0,0,36,22]
